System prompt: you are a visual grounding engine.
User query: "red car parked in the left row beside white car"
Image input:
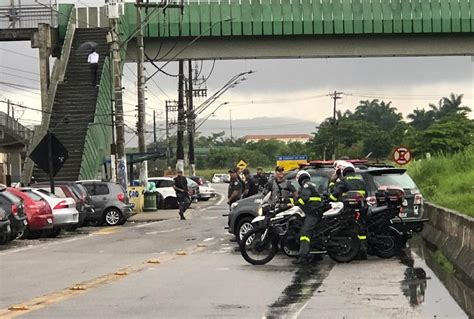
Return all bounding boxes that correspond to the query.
[7,188,54,239]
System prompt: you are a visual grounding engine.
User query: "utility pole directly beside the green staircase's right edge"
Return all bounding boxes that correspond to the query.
[108,0,128,192]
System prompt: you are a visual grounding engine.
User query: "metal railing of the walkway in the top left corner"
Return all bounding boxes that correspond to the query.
[0,0,58,29]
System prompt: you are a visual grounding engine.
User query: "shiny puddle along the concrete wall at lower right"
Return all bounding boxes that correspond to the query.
[398,236,474,318]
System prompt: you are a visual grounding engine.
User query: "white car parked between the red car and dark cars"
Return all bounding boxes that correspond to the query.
[21,187,79,237]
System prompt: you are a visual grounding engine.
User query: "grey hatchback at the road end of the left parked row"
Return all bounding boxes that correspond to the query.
[77,181,132,226]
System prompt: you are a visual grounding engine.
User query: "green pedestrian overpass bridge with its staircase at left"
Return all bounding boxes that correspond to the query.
[24,0,474,179]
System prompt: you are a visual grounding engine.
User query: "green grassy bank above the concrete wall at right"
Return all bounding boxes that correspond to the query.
[408,146,474,217]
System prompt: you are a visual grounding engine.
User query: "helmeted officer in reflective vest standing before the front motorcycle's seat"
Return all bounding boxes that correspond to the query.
[293,170,324,265]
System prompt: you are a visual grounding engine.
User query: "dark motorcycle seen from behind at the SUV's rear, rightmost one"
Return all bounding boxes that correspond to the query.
[364,186,411,258]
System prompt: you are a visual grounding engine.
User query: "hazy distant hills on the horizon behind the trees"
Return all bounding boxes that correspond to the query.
[125,117,318,147]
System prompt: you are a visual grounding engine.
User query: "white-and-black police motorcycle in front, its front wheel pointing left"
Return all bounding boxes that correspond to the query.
[240,194,360,265]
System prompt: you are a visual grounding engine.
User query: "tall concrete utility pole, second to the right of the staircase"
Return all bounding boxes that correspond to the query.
[136,0,148,186]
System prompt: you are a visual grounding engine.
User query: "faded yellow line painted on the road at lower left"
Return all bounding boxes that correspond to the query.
[0,246,204,319]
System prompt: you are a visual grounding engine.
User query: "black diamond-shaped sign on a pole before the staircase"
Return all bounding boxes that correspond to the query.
[29,133,69,193]
